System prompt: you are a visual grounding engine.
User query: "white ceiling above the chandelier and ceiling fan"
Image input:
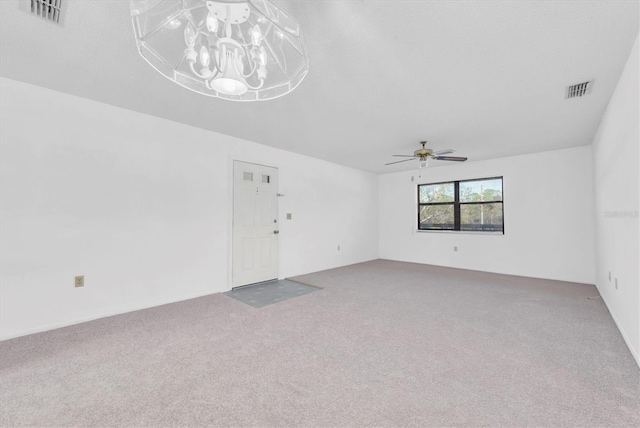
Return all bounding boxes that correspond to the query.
[0,0,639,173]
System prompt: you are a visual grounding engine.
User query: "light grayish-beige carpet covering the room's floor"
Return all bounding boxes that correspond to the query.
[0,260,640,427]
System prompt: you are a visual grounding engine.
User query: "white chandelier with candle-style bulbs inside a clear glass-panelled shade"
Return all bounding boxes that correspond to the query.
[131,0,309,101]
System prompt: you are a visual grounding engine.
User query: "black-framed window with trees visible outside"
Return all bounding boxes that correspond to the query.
[418,177,504,233]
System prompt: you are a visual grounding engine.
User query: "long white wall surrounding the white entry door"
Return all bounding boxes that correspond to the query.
[0,78,378,338]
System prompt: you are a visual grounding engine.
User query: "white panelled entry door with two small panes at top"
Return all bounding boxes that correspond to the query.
[232,161,279,287]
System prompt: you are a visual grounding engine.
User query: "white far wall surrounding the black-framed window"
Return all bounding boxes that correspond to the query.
[379,146,594,283]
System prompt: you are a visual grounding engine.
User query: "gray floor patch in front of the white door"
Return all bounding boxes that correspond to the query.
[222,279,319,308]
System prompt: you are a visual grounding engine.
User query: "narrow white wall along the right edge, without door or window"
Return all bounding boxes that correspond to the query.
[593,38,640,365]
